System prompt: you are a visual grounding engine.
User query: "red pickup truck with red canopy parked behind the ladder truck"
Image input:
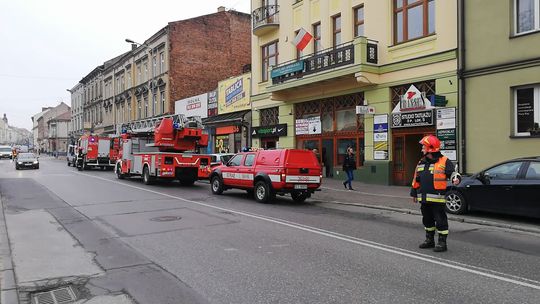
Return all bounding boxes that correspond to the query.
[210,149,322,203]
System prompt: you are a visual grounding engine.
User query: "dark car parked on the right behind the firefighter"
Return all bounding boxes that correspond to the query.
[446,156,540,218]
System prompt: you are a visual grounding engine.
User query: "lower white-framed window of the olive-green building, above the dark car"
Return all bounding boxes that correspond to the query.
[514,86,540,136]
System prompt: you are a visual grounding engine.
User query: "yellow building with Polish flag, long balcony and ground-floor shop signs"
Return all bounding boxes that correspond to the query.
[251,0,458,185]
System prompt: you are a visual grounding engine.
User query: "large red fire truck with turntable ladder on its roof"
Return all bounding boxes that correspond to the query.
[115,114,211,185]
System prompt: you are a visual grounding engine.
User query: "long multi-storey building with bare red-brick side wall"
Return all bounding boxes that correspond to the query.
[72,8,251,134]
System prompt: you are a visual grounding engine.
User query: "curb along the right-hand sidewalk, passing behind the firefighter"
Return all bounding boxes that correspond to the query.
[318,201,540,234]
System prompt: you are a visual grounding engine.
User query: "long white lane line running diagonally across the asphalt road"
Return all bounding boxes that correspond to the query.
[74,172,540,290]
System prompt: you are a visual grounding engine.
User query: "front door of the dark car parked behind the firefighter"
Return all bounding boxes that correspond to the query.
[467,161,523,212]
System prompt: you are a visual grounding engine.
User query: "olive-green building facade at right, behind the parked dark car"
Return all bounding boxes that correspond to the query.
[459,0,540,172]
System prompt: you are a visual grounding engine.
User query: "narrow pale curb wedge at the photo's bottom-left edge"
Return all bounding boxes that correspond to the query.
[0,195,19,304]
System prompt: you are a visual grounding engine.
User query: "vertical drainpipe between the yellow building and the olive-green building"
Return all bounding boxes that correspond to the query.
[457,0,467,173]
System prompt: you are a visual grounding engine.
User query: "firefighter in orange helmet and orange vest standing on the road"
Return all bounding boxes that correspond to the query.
[411,135,461,252]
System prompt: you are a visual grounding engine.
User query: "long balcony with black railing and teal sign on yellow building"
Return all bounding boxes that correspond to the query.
[266,37,380,94]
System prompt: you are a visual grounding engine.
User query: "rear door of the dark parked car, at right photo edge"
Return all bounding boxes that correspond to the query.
[512,161,540,218]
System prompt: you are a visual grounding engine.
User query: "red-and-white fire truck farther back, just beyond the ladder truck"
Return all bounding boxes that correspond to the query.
[76,135,116,170]
